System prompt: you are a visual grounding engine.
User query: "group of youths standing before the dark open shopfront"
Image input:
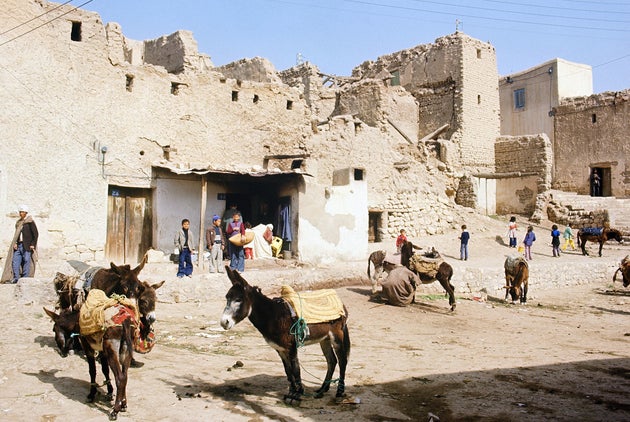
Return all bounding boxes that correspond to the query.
[175,204,273,278]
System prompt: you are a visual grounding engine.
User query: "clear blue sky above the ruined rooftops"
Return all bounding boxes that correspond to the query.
[85,0,630,93]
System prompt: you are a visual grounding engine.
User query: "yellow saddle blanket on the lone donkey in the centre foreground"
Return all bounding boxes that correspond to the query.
[280,285,346,324]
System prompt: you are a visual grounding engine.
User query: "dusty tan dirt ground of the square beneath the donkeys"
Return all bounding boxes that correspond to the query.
[0,219,630,421]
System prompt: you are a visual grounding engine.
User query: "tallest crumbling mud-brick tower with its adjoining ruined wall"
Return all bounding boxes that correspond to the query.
[352,32,500,171]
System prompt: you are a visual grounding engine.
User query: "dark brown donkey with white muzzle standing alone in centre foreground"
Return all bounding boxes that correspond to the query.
[221,266,350,404]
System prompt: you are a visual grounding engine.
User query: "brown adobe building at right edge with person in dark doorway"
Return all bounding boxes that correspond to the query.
[553,90,630,197]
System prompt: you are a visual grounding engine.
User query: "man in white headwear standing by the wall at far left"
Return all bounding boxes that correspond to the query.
[2,205,39,283]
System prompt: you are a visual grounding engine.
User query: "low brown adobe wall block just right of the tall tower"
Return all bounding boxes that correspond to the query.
[495,133,553,218]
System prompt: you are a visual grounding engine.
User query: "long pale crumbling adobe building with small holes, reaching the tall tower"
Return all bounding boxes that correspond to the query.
[0,0,508,270]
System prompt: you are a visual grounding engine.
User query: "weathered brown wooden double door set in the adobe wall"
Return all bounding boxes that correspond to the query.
[105,186,153,264]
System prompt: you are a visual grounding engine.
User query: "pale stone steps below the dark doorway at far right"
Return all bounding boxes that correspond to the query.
[550,190,630,233]
